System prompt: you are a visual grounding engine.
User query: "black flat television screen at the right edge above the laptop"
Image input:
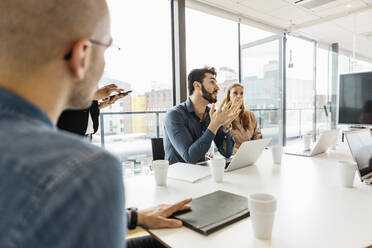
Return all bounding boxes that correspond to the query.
[338,72,372,126]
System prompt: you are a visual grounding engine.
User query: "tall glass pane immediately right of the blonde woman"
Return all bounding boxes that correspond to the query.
[241,36,283,145]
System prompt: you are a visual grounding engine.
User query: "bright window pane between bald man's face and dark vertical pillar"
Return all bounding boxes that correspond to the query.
[93,0,172,163]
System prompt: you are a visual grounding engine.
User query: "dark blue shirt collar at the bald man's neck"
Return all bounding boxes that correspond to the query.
[0,87,55,127]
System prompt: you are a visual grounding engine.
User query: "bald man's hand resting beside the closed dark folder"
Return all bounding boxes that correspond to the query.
[137,198,192,228]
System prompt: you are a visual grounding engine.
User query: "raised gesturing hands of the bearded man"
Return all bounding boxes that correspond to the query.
[208,98,243,134]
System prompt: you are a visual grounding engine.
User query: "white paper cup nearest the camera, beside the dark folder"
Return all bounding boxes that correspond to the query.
[248,194,276,239]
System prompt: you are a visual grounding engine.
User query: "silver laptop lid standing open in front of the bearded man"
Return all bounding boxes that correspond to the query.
[225,138,271,171]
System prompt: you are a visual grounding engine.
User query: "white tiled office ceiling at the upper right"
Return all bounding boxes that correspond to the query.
[190,0,372,60]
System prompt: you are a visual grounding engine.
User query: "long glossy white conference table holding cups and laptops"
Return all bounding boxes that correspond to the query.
[125,143,372,248]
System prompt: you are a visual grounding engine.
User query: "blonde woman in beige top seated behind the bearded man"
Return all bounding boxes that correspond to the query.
[225,83,262,154]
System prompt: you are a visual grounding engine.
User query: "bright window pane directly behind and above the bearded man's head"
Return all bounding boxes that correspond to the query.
[186,9,239,104]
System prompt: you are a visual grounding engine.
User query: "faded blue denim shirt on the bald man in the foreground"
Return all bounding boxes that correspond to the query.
[0,88,126,248]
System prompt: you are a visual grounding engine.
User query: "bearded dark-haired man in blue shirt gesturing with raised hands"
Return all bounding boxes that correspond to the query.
[164,67,241,164]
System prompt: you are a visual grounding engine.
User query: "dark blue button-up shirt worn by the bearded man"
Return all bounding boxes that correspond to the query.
[164,98,235,164]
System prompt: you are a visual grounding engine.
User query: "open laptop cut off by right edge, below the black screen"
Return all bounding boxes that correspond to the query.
[345,129,372,184]
